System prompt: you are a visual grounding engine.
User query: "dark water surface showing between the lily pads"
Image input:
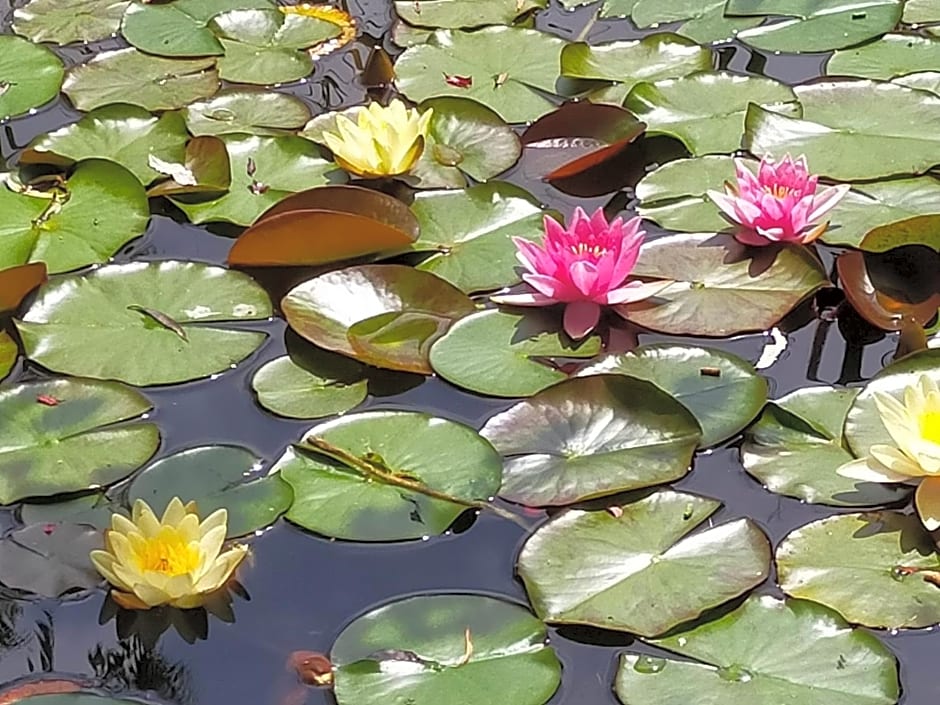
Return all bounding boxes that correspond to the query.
[0,0,940,705]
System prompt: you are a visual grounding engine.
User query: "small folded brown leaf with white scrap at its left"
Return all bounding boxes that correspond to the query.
[147,135,232,197]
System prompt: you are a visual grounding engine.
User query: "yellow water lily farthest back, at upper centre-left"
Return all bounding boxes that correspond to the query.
[323,99,433,179]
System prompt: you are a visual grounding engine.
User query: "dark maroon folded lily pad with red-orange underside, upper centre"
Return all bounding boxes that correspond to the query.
[522,102,646,181]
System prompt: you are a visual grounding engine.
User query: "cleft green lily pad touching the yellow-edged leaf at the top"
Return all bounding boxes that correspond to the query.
[211,10,342,85]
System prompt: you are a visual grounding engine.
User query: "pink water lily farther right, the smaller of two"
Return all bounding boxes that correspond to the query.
[708,154,850,245]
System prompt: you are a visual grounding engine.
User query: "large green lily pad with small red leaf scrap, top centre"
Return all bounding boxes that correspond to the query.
[395,27,566,122]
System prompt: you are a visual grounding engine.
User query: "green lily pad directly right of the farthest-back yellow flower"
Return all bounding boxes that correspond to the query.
[410,98,522,188]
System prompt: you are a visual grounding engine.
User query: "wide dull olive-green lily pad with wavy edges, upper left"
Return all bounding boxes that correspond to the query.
[62,47,219,111]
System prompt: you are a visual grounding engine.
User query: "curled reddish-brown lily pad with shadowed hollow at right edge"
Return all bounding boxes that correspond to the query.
[836,247,940,331]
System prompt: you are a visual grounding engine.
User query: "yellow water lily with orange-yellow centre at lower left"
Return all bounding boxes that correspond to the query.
[91,497,248,609]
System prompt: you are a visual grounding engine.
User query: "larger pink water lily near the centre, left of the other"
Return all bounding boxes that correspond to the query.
[491,208,669,340]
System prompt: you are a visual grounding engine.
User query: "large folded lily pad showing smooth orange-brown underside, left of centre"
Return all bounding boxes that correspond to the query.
[228,186,419,267]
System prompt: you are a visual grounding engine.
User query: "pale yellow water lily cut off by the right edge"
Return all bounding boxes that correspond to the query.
[838,375,940,531]
